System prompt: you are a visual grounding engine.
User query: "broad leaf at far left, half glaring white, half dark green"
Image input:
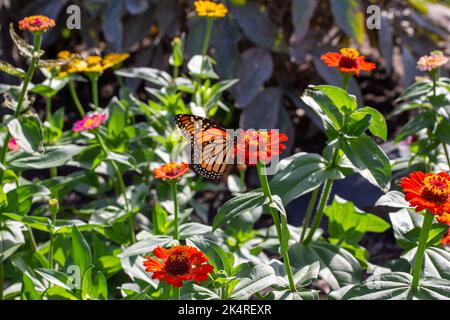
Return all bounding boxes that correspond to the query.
[7,114,43,153]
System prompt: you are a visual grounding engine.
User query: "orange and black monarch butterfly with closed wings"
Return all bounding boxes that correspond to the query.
[175,114,235,180]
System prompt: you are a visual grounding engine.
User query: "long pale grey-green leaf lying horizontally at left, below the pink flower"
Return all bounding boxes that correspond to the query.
[9,144,86,171]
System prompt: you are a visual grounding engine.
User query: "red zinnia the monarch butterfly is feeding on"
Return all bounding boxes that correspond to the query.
[235,129,288,165]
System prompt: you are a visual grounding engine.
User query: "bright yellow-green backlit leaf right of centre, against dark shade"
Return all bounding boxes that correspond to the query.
[325,196,390,244]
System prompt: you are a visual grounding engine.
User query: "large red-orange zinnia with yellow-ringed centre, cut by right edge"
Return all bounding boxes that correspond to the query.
[400,171,450,216]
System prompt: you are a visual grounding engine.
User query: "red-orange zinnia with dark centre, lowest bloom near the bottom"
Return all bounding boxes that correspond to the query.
[144,245,214,288]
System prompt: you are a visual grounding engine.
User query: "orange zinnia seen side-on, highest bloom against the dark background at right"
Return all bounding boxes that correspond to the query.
[320,48,376,76]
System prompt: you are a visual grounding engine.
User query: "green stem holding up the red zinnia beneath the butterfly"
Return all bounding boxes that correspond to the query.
[257,161,297,292]
